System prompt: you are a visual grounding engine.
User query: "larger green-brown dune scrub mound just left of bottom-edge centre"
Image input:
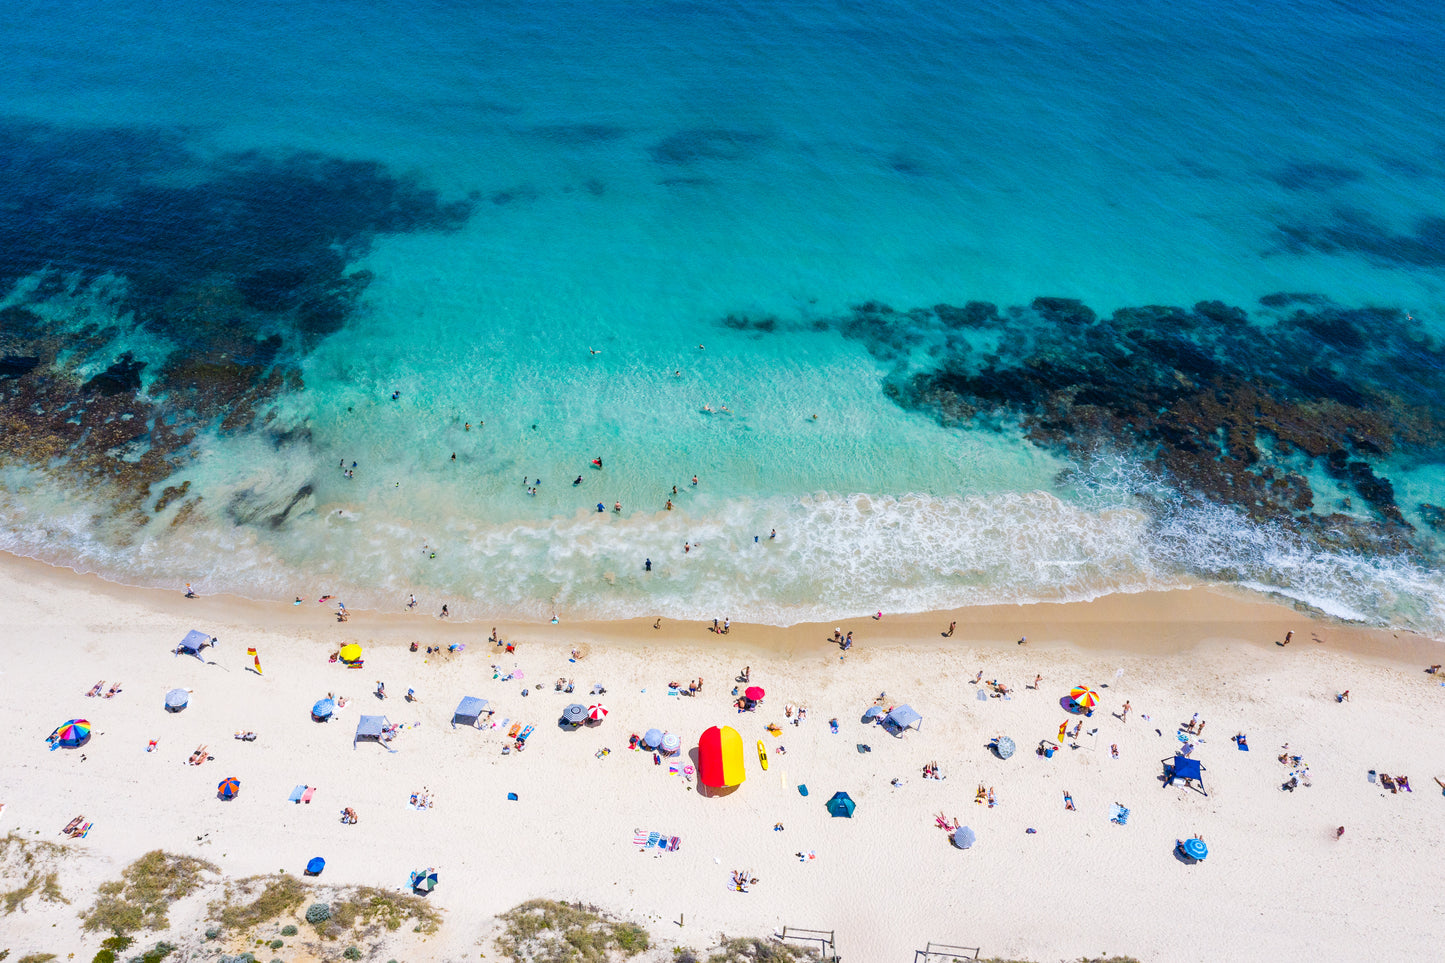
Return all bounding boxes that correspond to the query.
[497,899,650,963]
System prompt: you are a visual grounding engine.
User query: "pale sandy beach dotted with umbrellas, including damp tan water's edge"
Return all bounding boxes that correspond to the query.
[0,558,1445,963]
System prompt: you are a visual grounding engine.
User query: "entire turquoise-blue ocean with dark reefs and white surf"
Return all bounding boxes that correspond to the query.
[0,0,1445,633]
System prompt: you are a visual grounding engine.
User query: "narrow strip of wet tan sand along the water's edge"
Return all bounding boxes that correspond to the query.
[0,551,1445,665]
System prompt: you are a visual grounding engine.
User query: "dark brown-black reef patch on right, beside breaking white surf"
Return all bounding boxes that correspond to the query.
[720,294,1445,551]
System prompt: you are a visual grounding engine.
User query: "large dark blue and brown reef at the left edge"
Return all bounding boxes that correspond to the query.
[0,119,474,531]
